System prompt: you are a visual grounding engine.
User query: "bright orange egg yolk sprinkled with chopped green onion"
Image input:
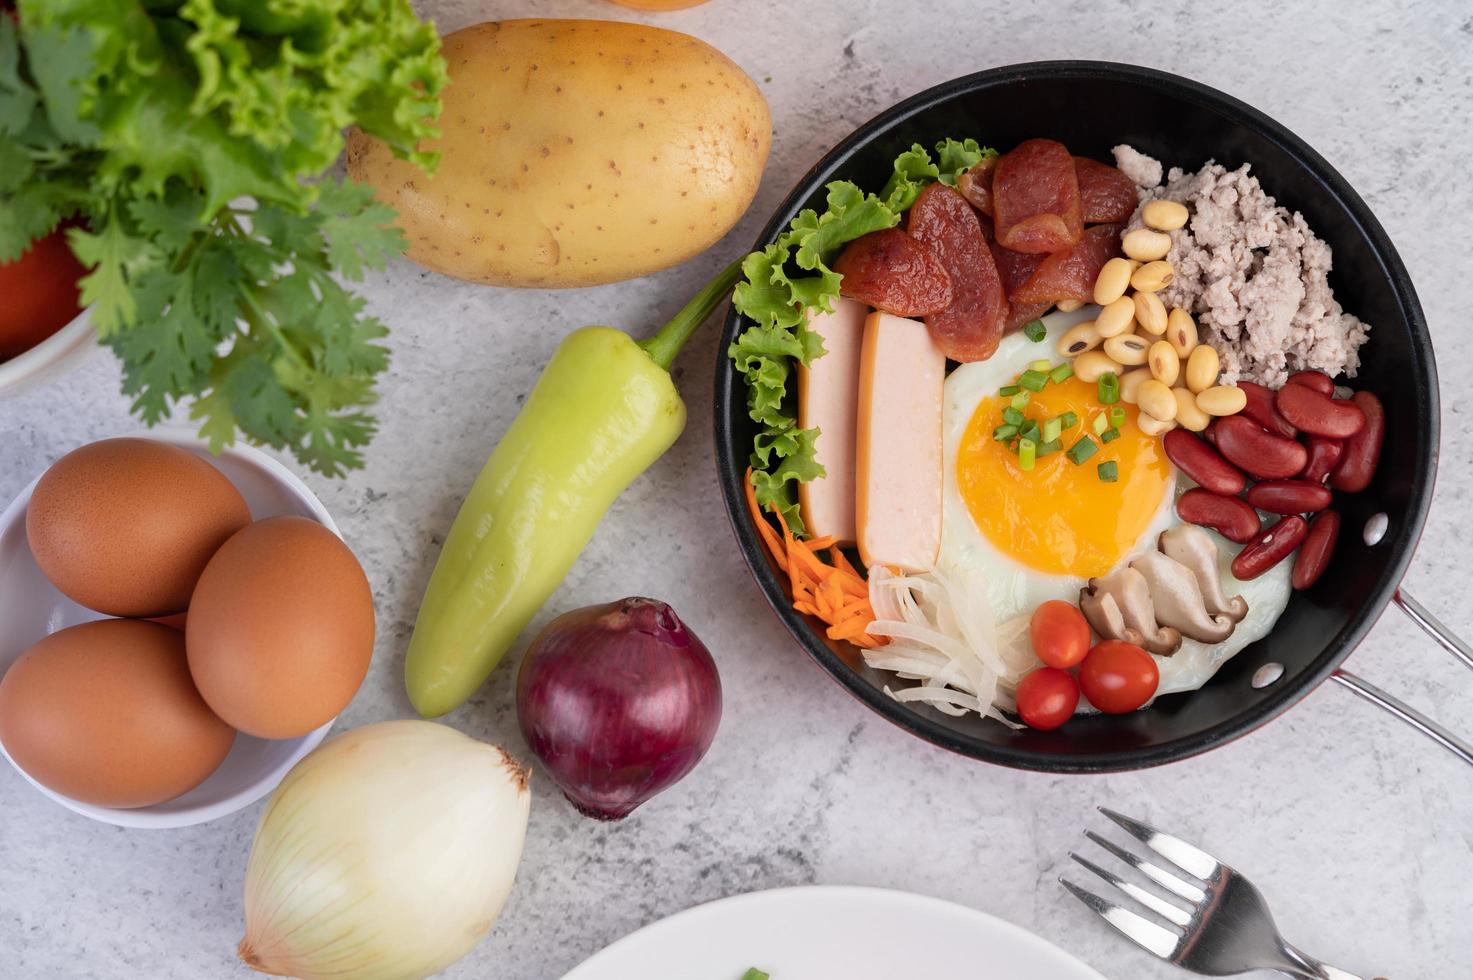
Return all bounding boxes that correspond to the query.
[956,377,1171,578]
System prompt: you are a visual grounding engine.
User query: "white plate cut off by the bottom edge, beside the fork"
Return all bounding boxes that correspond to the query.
[563,887,1105,980]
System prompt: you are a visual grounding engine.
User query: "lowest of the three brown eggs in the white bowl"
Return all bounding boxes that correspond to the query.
[0,619,236,806]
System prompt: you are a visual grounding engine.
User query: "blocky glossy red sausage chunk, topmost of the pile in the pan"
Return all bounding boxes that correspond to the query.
[993,140,1084,252]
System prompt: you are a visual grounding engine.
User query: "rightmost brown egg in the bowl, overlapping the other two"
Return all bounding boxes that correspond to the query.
[184,517,374,738]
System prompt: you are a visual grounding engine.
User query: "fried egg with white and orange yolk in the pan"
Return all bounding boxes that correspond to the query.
[937,307,1290,694]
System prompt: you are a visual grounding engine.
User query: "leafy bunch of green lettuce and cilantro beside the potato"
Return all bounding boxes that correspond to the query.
[0,0,446,476]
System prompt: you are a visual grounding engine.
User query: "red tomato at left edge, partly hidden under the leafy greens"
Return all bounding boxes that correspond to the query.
[0,228,87,361]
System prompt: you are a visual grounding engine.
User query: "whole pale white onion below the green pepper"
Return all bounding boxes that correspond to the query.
[232,721,532,980]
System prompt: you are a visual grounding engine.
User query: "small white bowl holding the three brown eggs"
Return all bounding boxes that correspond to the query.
[0,427,339,828]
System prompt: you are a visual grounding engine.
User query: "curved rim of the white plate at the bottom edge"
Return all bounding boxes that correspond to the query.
[561,884,1106,980]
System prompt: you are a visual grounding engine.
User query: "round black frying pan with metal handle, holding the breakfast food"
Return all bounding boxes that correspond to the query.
[714,62,1473,772]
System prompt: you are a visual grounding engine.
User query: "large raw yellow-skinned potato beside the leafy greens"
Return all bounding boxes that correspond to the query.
[348,19,772,287]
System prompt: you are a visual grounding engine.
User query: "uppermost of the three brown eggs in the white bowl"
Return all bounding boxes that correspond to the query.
[25,439,250,617]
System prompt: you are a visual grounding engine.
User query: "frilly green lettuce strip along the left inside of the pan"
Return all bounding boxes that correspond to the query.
[726,139,996,535]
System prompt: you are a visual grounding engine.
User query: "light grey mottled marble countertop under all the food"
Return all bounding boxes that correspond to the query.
[0,0,1473,980]
